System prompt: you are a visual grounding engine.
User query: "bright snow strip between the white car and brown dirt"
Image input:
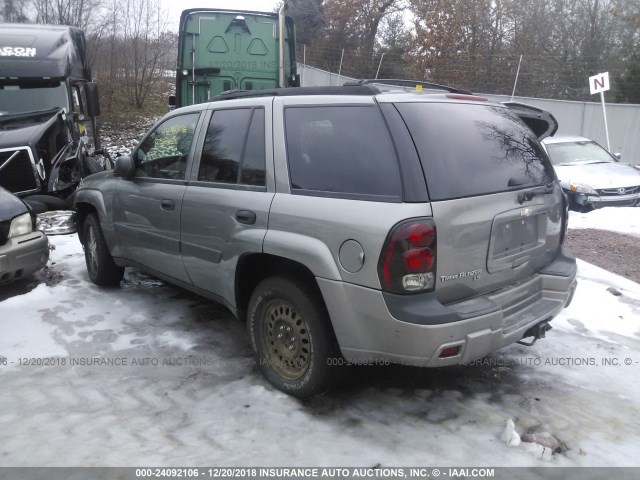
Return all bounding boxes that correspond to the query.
[569,207,640,237]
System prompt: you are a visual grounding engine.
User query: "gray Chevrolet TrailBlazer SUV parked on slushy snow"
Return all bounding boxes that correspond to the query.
[75,82,576,397]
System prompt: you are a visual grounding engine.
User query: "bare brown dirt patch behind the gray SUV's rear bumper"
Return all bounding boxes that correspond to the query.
[564,229,640,283]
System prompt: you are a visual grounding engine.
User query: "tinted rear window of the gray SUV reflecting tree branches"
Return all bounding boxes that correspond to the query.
[396,103,555,200]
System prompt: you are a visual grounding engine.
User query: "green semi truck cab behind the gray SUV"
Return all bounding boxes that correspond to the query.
[170,4,300,107]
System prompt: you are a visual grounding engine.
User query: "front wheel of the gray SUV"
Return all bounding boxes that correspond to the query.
[83,213,124,287]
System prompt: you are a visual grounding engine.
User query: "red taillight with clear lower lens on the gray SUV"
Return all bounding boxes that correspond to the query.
[379,219,436,293]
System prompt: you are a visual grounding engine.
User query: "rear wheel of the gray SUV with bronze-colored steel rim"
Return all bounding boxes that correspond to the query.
[247,277,344,398]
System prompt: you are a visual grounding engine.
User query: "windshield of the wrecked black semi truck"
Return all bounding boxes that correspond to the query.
[0,80,69,115]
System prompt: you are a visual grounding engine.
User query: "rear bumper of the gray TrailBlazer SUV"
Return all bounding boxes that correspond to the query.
[318,250,577,367]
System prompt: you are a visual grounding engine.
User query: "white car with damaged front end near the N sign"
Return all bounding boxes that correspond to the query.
[542,135,640,211]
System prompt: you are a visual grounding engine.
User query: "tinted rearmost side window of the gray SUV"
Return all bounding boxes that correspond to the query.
[285,106,402,201]
